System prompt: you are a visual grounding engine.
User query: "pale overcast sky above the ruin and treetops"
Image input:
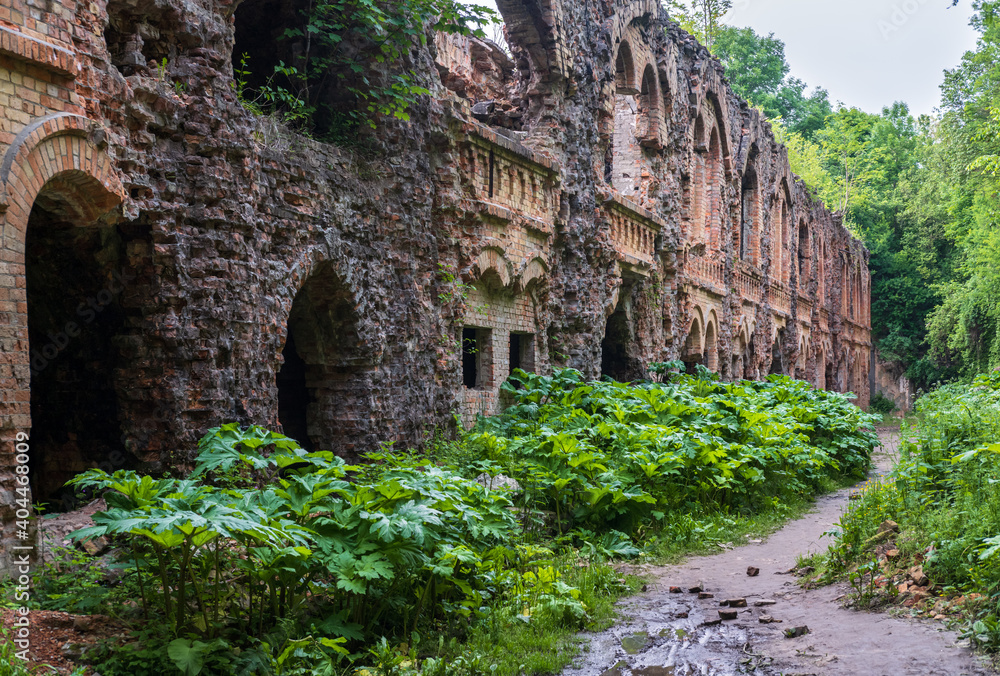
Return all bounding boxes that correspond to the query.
[463,0,976,114]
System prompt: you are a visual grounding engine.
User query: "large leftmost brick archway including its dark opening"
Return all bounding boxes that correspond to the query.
[0,113,127,521]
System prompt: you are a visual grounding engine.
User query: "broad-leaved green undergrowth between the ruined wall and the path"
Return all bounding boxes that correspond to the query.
[1,370,875,676]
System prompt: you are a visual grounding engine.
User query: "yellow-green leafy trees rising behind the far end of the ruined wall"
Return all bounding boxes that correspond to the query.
[777,103,955,387]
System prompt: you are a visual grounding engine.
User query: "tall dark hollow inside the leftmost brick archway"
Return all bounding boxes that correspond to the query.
[25,189,139,511]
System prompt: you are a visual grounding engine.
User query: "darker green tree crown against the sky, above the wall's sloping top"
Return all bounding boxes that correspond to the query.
[712,26,833,138]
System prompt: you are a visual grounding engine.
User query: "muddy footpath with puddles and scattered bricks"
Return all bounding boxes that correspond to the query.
[563,432,995,676]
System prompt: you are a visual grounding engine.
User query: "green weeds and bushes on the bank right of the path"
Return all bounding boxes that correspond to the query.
[820,372,1000,652]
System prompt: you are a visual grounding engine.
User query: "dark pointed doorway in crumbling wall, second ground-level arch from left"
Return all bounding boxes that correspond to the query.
[275,263,374,459]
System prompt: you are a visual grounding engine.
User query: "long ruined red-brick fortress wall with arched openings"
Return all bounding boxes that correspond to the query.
[0,0,871,560]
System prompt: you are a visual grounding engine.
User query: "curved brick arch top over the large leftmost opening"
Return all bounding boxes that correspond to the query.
[0,113,125,226]
